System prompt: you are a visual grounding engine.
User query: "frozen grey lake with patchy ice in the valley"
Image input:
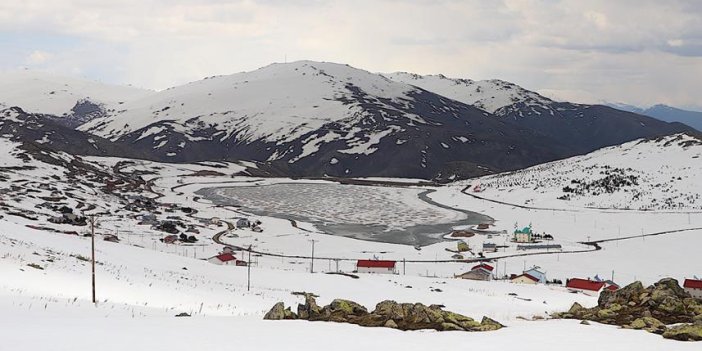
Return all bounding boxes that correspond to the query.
[198,183,492,246]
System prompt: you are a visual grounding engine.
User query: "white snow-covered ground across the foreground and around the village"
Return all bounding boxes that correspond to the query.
[0,140,702,350]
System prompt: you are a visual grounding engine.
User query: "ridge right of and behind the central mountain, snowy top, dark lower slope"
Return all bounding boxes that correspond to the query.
[386,73,692,157]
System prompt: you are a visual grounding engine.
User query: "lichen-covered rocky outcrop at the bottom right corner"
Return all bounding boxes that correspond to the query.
[554,278,702,340]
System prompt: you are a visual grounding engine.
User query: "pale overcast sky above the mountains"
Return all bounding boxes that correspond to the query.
[0,0,702,110]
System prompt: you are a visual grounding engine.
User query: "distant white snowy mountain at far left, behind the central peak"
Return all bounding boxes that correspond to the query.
[0,70,153,126]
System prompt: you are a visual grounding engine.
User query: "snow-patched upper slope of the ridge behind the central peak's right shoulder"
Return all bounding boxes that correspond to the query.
[384,72,553,113]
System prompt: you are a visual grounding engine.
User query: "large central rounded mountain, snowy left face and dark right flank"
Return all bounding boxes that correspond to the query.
[80,61,584,178]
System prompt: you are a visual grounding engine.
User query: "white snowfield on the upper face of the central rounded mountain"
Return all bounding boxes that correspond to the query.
[83,61,425,141]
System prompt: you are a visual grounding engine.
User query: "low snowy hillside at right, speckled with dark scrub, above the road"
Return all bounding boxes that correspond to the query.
[472,134,702,210]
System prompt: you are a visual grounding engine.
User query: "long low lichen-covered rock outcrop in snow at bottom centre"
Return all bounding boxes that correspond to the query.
[264,294,504,331]
